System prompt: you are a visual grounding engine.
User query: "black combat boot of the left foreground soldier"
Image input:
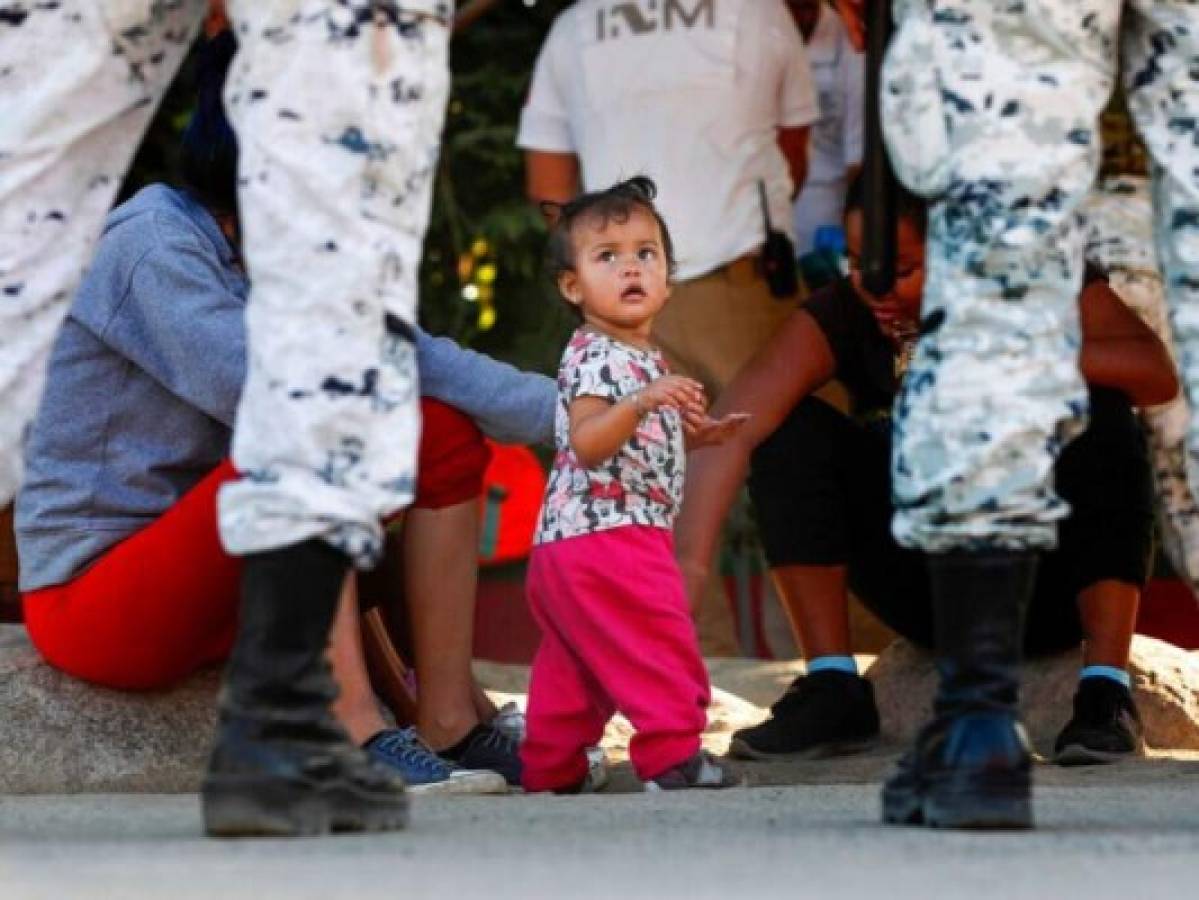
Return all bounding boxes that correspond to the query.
[201,540,408,836]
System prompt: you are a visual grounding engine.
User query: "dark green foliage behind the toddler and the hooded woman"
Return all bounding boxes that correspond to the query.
[120,0,571,373]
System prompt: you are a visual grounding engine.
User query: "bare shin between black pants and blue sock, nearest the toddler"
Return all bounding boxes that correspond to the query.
[771,566,851,660]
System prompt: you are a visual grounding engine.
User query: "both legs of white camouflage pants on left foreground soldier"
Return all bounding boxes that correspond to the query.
[0,0,452,564]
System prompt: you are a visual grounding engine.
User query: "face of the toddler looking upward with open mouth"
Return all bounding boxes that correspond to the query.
[558,207,670,338]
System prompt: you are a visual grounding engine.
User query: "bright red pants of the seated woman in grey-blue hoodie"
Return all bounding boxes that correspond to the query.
[23,399,490,689]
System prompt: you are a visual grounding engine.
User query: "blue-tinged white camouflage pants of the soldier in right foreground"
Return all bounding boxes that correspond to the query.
[882,0,1199,552]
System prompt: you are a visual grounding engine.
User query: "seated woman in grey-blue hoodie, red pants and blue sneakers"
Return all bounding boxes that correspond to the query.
[16,36,555,791]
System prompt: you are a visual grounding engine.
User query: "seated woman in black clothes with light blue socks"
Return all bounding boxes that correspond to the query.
[676,177,1177,763]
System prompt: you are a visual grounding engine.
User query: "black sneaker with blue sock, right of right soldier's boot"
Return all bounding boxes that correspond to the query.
[1054,678,1145,766]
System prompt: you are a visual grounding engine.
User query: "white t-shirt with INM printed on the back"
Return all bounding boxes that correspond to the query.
[517,0,819,280]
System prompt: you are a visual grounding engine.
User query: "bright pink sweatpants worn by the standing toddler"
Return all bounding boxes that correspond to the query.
[520,525,711,791]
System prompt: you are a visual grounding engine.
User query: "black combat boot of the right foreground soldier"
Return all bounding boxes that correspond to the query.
[882,551,1036,828]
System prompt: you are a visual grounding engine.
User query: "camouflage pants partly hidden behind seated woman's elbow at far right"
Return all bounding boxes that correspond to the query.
[1083,175,1199,592]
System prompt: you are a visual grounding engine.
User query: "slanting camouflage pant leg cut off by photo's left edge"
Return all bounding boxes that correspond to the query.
[0,0,206,506]
